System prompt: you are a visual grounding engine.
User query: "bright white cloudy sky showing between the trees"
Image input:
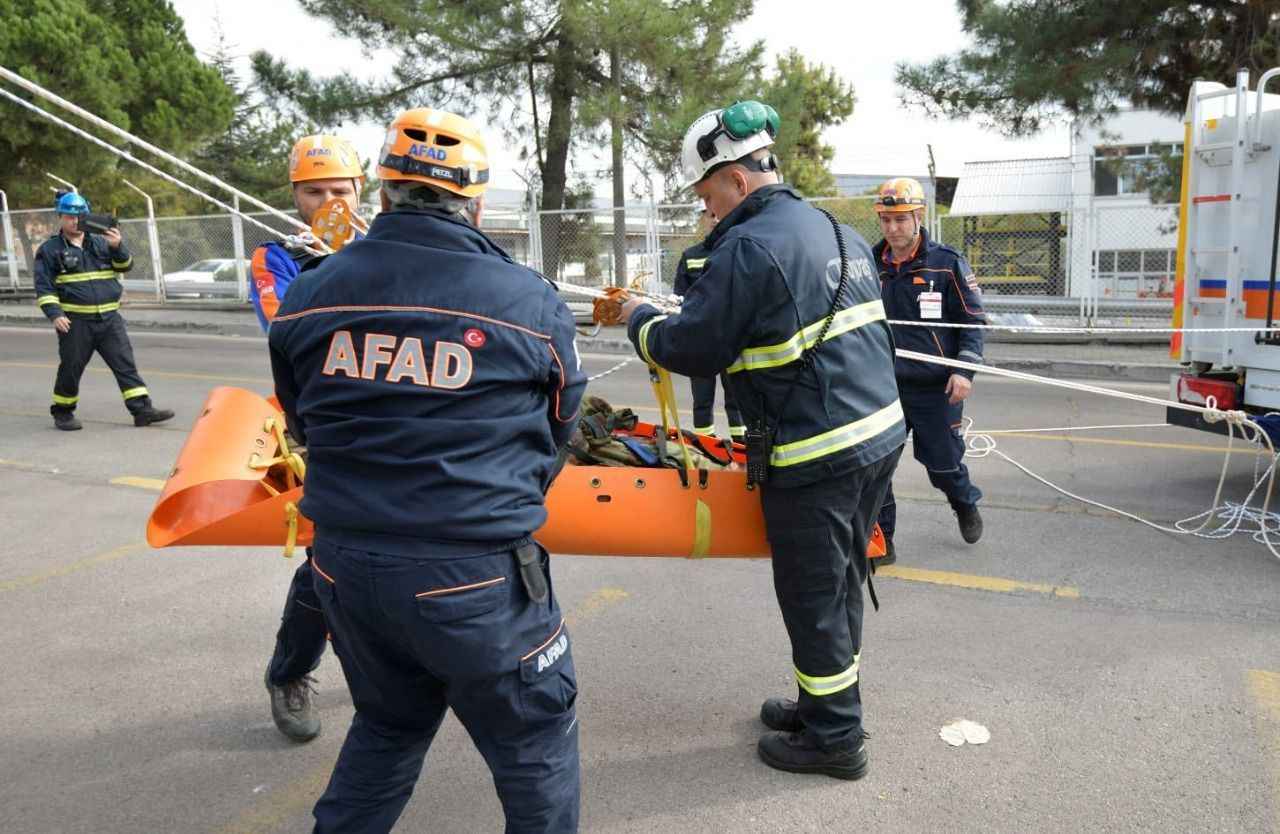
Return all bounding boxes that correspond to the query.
[173,0,1068,191]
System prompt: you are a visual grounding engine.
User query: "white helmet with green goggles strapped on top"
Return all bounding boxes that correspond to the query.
[680,101,778,185]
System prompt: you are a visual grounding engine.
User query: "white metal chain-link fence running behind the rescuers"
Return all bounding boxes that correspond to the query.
[0,191,1178,326]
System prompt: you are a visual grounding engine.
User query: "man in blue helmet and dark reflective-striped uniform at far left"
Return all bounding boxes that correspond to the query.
[35,192,173,431]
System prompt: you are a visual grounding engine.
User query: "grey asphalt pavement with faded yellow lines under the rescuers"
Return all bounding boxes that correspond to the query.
[0,322,1280,834]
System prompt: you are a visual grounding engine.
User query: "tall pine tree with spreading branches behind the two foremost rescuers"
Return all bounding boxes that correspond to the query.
[255,0,760,271]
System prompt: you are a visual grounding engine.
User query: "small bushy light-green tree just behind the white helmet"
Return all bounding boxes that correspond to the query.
[759,49,856,197]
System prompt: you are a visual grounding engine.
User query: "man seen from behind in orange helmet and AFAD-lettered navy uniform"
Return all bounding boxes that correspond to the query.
[269,109,586,834]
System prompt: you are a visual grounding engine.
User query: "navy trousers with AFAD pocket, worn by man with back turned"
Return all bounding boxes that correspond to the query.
[312,530,579,834]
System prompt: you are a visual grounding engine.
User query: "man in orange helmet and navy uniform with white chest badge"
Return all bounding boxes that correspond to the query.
[873,177,987,564]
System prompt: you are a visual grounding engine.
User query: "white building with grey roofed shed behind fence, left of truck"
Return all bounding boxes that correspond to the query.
[943,110,1184,299]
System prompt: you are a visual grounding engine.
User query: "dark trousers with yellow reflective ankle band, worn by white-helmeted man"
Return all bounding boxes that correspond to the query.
[760,448,902,751]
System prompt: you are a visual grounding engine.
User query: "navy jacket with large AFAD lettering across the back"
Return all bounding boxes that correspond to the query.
[268,211,586,555]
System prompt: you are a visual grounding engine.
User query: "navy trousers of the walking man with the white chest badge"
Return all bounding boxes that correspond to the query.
[879,388,982,539]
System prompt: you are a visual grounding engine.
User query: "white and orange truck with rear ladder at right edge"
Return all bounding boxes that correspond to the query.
[1167,68,1280,434]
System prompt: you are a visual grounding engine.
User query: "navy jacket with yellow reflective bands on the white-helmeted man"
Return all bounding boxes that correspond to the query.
[628,184,906,487]
